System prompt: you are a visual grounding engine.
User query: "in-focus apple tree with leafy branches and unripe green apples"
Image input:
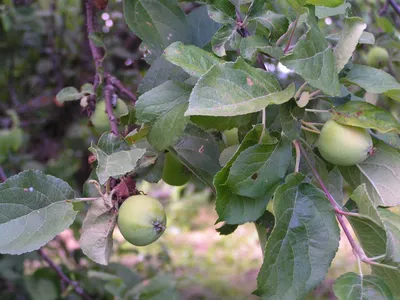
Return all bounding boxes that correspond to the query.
[0,0,400,300]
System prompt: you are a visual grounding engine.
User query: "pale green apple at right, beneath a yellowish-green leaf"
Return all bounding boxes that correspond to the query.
[317,119,373,166]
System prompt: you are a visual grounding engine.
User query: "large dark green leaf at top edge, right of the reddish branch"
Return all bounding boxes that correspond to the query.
[124,0,191,49]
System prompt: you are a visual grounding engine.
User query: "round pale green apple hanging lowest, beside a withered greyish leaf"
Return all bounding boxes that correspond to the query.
[118,195,167,246]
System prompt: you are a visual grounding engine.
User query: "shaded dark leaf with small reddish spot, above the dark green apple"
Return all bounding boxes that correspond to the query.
[169,123,221,187]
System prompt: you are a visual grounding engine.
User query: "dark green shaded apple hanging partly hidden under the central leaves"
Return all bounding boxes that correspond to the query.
[162,152,191,186]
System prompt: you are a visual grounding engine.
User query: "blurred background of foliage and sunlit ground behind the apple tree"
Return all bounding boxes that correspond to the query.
[0,0,400,300]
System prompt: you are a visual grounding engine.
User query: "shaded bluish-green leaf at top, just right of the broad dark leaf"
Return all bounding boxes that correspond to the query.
[186,6,221,48]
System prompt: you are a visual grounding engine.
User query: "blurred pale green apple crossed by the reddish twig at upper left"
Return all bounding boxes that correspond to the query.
[90,99,128,132]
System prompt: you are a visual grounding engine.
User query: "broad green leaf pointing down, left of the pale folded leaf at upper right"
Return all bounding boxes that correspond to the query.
[281,25,340,96]
